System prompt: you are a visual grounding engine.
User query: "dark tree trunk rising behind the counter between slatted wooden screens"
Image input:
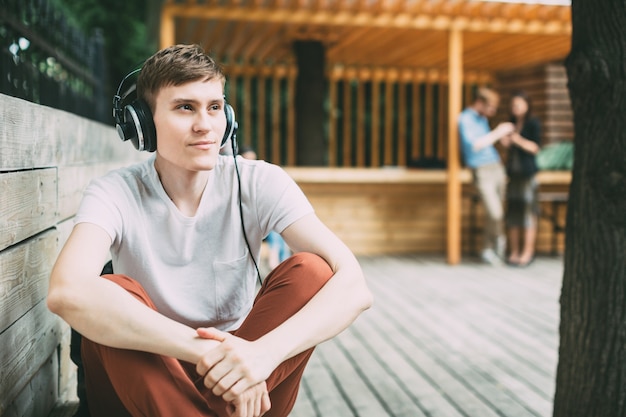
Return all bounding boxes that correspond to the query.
[294,41,327,166]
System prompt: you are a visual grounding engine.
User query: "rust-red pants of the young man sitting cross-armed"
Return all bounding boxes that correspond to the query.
[82,253,332,417]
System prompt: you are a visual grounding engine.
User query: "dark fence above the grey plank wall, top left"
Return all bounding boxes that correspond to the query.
[0,0,111,123]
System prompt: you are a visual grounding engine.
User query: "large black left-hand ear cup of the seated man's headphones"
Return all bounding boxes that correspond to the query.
[117,99,156,152]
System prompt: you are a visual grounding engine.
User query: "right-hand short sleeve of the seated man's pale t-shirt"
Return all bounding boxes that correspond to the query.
[256,163,314,235]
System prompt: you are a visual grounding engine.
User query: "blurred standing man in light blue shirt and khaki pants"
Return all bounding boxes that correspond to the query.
[458,88,515,265]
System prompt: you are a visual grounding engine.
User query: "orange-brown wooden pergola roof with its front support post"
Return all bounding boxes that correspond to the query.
[160,0,571,264]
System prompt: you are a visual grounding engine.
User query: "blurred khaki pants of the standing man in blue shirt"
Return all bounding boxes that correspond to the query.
[473,163,506,250]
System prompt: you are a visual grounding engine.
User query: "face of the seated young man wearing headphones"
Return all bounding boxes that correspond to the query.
[154,78,226,171]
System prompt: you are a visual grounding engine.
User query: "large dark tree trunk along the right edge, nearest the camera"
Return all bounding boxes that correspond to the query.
[554,0,626,417]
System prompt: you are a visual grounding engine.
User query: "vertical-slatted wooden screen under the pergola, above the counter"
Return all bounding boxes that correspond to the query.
[226,65,491,168]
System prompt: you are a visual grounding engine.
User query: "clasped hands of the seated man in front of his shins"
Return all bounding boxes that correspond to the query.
[196,328,275,417]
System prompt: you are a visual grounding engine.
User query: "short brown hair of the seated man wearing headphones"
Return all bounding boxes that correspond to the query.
[137,45,226,111]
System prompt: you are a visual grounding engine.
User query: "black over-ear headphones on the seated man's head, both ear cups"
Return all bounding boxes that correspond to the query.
[113,68,237,155]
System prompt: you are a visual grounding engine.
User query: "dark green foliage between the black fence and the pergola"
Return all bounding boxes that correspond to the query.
[54,0,158,91]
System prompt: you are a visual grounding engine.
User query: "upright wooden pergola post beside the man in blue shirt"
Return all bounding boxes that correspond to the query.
[447,27,463,265]
